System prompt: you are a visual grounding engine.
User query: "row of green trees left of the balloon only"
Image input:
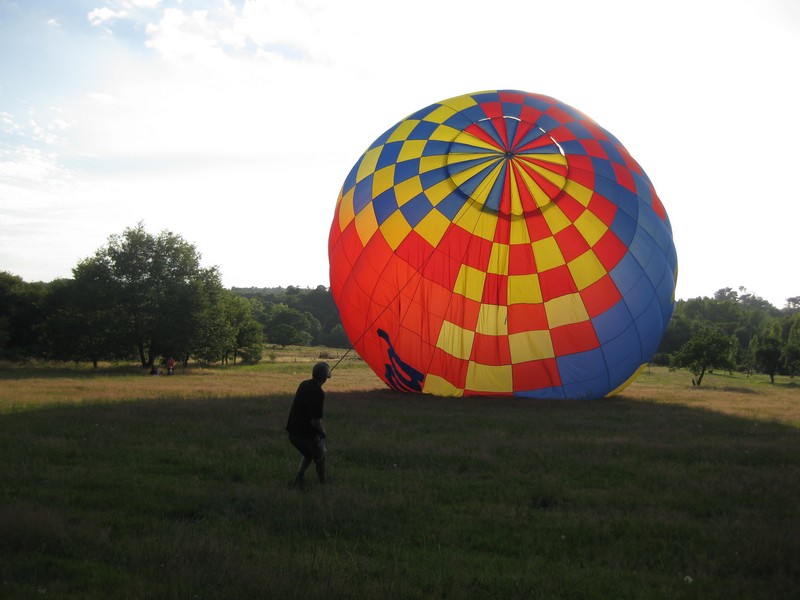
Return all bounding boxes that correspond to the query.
[0,223,348,368]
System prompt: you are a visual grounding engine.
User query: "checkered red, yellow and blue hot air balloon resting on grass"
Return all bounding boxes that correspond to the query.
[329,90,677,399]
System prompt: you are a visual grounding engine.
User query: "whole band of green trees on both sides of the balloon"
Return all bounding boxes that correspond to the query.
[0,223,800,385]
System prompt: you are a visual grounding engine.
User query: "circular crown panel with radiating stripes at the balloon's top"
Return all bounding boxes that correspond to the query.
[446,115,569,216]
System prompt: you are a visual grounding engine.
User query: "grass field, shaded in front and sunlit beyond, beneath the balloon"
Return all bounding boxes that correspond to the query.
[0,349,800,600]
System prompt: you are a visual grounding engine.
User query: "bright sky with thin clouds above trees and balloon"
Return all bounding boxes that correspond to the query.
[0,0,800,308]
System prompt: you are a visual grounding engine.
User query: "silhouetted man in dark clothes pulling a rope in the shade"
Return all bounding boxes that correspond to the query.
[286,362,331,488]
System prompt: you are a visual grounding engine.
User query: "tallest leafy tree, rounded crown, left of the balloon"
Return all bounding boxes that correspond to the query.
[73,223,226,367]
